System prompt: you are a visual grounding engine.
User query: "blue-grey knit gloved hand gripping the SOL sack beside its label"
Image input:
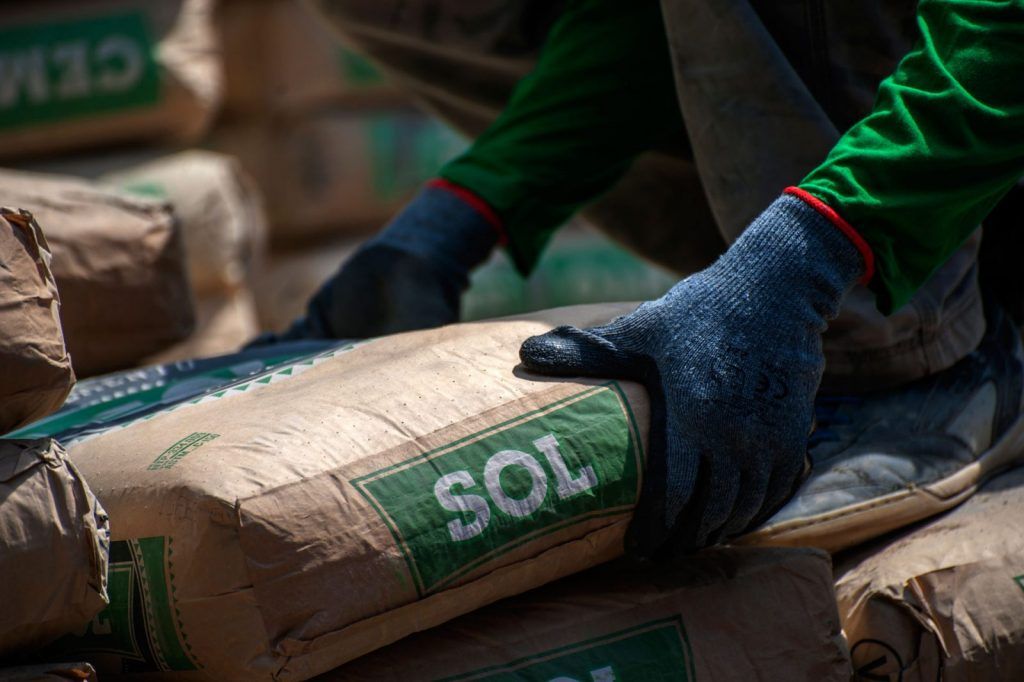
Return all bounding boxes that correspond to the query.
[519,190,870,558]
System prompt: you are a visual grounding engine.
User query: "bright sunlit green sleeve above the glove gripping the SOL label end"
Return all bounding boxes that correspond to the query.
[800,0,1024,313]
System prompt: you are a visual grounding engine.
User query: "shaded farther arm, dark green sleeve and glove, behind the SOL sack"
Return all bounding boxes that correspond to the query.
[257,0,683,343]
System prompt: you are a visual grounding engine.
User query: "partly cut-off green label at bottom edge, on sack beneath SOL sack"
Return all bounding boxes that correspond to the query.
[449,617,696,682]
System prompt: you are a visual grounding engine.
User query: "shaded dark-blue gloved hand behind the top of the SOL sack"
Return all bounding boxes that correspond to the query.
[260,180,500,345]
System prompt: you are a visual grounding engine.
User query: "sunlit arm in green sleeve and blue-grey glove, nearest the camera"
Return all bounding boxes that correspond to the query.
[520,0,1024,555]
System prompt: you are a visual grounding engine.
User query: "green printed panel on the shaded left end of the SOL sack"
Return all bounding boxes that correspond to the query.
[51,537,198,673]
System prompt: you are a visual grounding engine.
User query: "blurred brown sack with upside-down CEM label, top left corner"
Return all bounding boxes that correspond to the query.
[0,0,220,160]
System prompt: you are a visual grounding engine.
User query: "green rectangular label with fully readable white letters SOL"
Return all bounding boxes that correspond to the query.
[351,382,643,595]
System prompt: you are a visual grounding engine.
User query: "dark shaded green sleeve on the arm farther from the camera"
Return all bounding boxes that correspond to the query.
[440,0,683,274]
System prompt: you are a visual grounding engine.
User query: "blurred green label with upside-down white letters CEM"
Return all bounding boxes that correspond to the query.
[0,12,160,129]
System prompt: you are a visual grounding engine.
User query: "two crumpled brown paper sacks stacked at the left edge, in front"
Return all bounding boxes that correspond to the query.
[0,208,109,656]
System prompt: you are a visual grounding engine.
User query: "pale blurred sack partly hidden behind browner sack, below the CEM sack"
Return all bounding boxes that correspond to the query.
[100,151,266,296]
